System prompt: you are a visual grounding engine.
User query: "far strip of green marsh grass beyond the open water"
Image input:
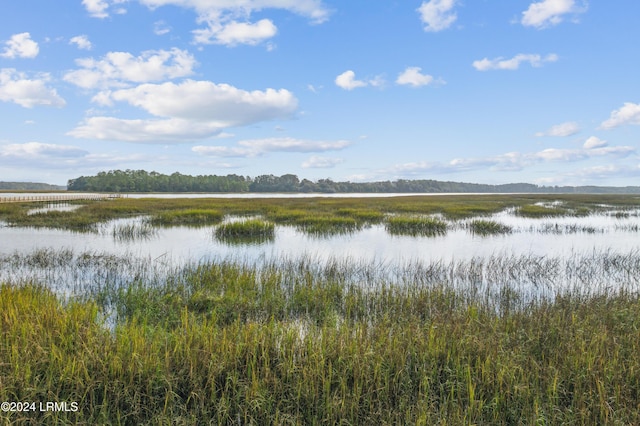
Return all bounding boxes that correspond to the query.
[0,194,640,230]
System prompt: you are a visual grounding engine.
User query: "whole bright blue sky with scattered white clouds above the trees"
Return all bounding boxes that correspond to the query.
[0,0,640,186]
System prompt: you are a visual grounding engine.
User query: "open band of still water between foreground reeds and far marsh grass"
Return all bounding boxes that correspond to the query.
[0,206,640,265]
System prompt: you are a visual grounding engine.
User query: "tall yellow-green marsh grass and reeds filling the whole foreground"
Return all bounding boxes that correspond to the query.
[0,251,640,425]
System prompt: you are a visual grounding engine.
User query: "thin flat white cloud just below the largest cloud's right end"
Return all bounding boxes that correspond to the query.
[192,137,351,157]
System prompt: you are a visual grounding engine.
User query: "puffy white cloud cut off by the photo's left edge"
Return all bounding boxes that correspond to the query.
[0,68,66,108]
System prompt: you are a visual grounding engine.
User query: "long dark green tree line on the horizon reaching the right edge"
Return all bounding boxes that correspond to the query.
[67,170,640,193]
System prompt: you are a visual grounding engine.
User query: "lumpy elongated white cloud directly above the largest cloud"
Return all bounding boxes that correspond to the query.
[64,48,196,89]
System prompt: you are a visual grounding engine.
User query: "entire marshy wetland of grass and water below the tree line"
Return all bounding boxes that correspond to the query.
[0,194,640,424]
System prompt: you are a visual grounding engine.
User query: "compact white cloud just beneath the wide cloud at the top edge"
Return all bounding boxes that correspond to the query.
[194,19,278,46]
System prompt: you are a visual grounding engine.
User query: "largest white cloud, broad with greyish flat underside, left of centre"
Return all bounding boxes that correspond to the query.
[68,80,297,142]
